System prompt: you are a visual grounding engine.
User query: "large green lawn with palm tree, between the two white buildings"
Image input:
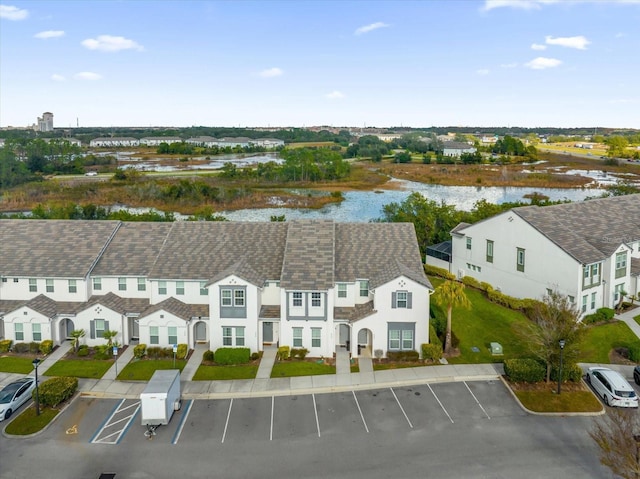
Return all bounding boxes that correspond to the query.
[429,277,529,364]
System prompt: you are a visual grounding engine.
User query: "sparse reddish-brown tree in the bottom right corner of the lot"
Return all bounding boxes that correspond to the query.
[589,409,640,479]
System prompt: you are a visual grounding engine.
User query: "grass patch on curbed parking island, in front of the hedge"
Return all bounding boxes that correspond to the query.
[515,390,602,413]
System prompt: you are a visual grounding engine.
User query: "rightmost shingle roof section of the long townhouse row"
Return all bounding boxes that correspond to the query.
[336,223,433,289]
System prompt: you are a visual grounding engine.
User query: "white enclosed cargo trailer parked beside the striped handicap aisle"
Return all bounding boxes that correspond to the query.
[140,369,181,436]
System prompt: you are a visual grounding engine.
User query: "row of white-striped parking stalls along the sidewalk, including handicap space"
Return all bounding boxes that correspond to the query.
[50,380,526,447]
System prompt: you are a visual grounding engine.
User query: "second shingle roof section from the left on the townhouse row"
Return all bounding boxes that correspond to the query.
[91,222,171,276]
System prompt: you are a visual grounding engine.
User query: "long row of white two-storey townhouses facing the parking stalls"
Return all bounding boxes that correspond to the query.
[0,220,433,357]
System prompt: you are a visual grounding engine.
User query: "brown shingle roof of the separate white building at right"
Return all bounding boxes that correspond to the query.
[511,194,640,264]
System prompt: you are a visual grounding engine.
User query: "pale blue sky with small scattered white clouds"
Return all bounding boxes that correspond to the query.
[0,0,640,128]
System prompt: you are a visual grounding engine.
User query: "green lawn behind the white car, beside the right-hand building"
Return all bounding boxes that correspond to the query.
[579,321,640,364]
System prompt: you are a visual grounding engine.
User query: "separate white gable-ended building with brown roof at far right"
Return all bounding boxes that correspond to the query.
[426,194,640,314]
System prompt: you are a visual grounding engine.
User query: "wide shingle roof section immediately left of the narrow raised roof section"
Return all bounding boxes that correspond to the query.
[149,221,287,281]
